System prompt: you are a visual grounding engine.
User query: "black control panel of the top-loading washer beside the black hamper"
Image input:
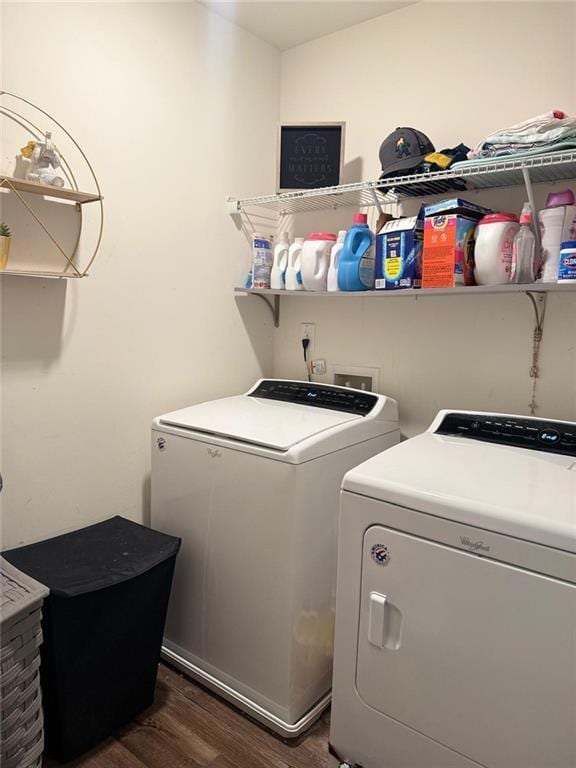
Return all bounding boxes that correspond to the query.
[250,379,378,416]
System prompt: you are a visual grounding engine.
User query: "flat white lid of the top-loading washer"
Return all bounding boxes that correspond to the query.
[159,395,362,452]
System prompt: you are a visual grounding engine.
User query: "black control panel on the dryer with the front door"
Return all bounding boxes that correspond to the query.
[436,413,576,456]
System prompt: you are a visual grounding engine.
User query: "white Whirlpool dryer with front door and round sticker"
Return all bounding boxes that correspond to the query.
[330,411,576,768]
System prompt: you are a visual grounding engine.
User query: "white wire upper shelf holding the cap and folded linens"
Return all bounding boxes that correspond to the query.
[228,150,576,216]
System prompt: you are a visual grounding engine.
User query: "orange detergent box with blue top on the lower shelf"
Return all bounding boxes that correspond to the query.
[422,198,490,288]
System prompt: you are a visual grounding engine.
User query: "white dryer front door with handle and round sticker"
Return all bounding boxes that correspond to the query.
[356,526,576,768]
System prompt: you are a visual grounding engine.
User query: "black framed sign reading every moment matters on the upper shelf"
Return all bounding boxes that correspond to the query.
[278,123,346,192]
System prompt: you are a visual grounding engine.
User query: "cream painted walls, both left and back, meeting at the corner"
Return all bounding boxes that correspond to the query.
[1,2,576,547]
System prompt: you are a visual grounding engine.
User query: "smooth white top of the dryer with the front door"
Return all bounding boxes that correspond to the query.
[343,412,576,552]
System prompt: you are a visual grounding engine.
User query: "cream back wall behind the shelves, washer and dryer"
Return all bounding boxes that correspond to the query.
[274,2,576,434]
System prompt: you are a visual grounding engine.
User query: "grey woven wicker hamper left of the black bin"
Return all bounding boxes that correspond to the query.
[0,558,48,768]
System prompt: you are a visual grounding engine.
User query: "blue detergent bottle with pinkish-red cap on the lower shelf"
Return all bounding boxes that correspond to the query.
[338,213,376,291]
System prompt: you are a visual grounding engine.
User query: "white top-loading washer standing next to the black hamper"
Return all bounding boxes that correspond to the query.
[152,380,400,737]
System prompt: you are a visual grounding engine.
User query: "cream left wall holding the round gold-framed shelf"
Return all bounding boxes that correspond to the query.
[2,2,279,548]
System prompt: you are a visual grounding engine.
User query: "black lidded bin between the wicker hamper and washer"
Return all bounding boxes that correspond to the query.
[4,517,180,762]
